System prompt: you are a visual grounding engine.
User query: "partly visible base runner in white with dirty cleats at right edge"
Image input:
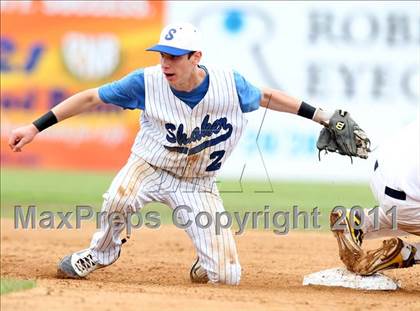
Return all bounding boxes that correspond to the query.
[331,119,420,275]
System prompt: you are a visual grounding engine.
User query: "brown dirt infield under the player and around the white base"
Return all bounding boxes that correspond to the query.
[1,219,420,311]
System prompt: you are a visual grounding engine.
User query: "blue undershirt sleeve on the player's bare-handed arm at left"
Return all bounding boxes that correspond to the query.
[98,69,146,110]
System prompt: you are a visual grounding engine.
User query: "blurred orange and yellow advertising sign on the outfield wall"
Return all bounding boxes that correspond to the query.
[0,1,163,169]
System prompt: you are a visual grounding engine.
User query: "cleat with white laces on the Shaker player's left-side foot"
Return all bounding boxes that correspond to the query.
[57,249,105,279]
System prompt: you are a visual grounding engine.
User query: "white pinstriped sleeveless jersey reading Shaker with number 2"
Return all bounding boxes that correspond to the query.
[132,65,246,177]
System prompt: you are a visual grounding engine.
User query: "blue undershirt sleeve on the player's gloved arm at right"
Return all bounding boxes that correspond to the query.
[233,71,261,113]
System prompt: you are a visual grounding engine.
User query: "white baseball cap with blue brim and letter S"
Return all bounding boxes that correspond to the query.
[146,23,202,56]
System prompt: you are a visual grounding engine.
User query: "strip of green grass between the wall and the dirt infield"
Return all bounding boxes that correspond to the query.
[0,168,375,230]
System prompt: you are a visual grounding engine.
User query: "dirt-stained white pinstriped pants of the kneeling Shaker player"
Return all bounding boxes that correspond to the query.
[90,154,241,285]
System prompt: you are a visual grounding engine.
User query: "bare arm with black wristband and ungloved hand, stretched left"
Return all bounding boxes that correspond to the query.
[9,89,103,152]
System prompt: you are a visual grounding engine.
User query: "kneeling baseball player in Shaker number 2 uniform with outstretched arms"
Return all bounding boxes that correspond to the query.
[9,23,368,285]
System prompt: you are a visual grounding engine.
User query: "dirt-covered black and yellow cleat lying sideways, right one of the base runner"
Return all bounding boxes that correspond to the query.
[354,238,417,275]
